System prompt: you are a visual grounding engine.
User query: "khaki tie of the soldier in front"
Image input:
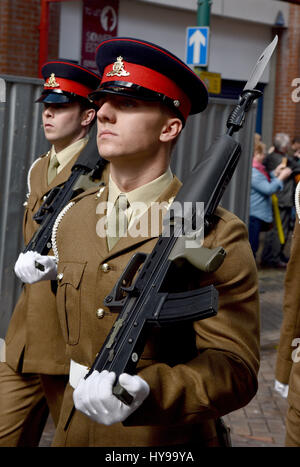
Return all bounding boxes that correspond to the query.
[107,193,129,250]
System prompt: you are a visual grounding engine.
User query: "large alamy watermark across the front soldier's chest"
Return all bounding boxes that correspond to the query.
[96,201,204,248]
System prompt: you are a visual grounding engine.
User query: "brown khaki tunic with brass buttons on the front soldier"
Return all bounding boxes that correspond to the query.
[54,177,259,446]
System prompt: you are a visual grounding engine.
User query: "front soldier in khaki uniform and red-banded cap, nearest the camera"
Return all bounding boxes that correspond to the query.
[21,38,259,446]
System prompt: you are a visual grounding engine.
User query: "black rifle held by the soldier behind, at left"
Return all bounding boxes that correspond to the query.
[23,130,106,258]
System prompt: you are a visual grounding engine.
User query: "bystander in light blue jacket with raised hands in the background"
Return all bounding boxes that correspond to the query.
[249,142,291,258]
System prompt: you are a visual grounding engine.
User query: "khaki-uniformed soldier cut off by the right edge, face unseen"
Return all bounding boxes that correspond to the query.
[275,183,300,447]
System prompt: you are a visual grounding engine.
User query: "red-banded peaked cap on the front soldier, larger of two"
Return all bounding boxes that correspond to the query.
[90,37,208,121]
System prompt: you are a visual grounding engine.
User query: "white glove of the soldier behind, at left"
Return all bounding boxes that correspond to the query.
[15,251,57,284]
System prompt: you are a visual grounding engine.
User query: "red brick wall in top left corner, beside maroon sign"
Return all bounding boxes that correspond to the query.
[0,0,60,77]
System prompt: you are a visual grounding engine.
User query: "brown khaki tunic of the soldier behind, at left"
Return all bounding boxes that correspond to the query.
[5,148,84,375]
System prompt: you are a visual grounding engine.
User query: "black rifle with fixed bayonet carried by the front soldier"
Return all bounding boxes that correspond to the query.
[85,36,277,405]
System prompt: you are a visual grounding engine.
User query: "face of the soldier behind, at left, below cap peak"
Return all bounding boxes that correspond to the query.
[43,102,82,145]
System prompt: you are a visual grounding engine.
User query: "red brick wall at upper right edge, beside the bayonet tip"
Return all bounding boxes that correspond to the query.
[273,4,300,138]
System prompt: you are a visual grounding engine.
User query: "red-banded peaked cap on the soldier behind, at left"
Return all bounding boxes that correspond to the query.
[36,60,101,103]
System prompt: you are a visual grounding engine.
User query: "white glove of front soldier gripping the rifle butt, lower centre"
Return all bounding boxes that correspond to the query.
[73,370,150,426]
